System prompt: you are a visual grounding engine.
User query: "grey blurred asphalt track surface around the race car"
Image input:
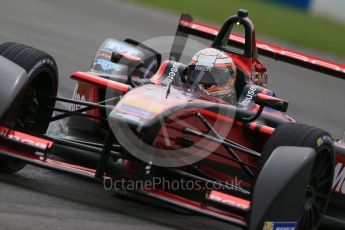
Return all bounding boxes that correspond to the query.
[0,0,345,230]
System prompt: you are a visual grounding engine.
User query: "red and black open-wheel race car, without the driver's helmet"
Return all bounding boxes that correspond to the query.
[0,10,345,230]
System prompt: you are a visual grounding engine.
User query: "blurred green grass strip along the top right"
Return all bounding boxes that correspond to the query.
[134,0,345,57]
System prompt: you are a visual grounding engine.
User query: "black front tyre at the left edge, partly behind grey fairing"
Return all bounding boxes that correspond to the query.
[0,42,58,173]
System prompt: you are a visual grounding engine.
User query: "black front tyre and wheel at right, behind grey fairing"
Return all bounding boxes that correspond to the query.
[258,123,334,230]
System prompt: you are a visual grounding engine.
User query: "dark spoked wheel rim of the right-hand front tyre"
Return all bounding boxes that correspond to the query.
[299,150,333,230]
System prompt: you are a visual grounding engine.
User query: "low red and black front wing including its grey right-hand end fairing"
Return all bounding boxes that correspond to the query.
[0,127,315,229]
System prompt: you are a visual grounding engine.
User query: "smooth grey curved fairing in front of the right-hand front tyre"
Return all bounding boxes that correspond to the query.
[248,147,316,230]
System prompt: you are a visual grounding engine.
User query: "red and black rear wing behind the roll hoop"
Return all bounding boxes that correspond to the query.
[170,14,345,79]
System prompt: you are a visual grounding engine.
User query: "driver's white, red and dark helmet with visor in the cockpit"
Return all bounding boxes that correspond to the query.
[185,48,236,104]
